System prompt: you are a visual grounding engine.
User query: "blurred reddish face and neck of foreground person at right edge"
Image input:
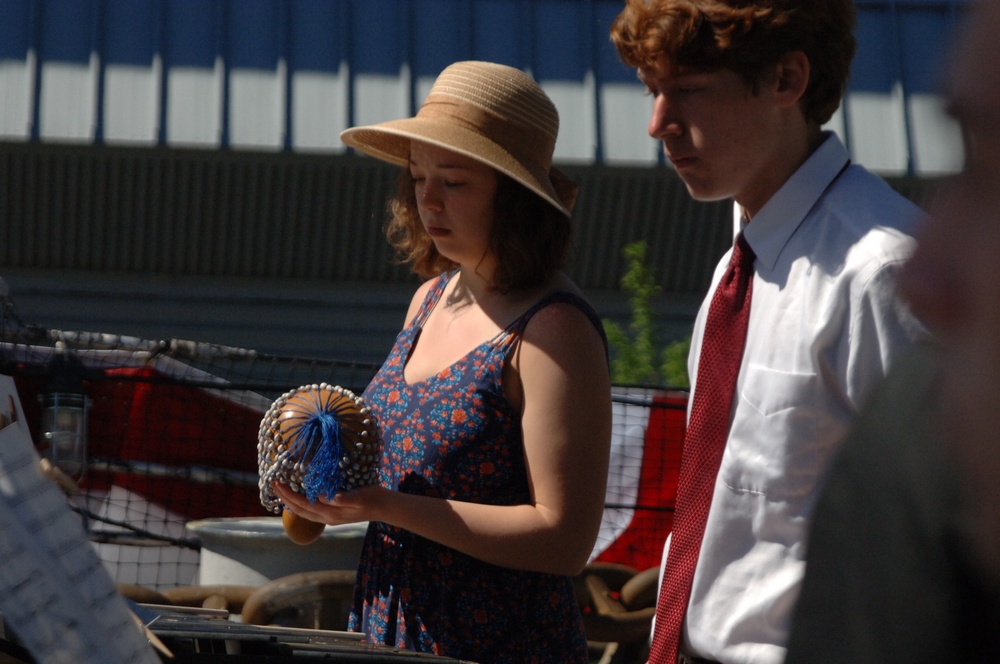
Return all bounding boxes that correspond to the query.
[902,2,1000,575]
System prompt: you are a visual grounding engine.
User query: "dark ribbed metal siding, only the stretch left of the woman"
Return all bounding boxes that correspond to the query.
[0,144,405,281]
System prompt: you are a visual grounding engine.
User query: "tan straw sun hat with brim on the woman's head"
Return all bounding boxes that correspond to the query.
[340,61,576,216]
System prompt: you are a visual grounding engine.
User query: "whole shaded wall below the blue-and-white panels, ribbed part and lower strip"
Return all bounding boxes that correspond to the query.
[0,142,933,362]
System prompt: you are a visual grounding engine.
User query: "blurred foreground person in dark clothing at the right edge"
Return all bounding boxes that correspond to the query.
[786,0,1000,664]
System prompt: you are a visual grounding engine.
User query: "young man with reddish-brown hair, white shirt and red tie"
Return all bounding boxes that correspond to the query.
[611,0,922,664]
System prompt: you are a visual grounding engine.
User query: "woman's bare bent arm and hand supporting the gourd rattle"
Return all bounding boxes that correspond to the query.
[276,304,611,575]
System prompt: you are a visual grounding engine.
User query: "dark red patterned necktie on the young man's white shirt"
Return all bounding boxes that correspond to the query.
[649,233,754,664]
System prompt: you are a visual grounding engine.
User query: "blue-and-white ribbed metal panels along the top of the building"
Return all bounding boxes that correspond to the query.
[0,0,968,174]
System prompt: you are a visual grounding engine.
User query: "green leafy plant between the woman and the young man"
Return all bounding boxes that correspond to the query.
[604,240,691,388]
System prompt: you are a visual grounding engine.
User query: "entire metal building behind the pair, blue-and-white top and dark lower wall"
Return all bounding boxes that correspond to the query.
[0,0,956,360]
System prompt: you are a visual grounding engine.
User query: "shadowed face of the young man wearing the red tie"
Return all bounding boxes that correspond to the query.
[638,58,787,217]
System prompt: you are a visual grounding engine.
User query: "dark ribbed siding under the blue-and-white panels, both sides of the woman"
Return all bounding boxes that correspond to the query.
[0,143,926,295]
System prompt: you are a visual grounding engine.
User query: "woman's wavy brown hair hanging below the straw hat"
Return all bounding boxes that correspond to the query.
[386,168,571,293]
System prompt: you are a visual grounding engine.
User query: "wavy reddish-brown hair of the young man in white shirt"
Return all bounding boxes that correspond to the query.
[611,0,857,125]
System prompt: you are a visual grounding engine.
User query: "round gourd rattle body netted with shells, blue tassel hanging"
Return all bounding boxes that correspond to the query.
[257,383,382,514]
